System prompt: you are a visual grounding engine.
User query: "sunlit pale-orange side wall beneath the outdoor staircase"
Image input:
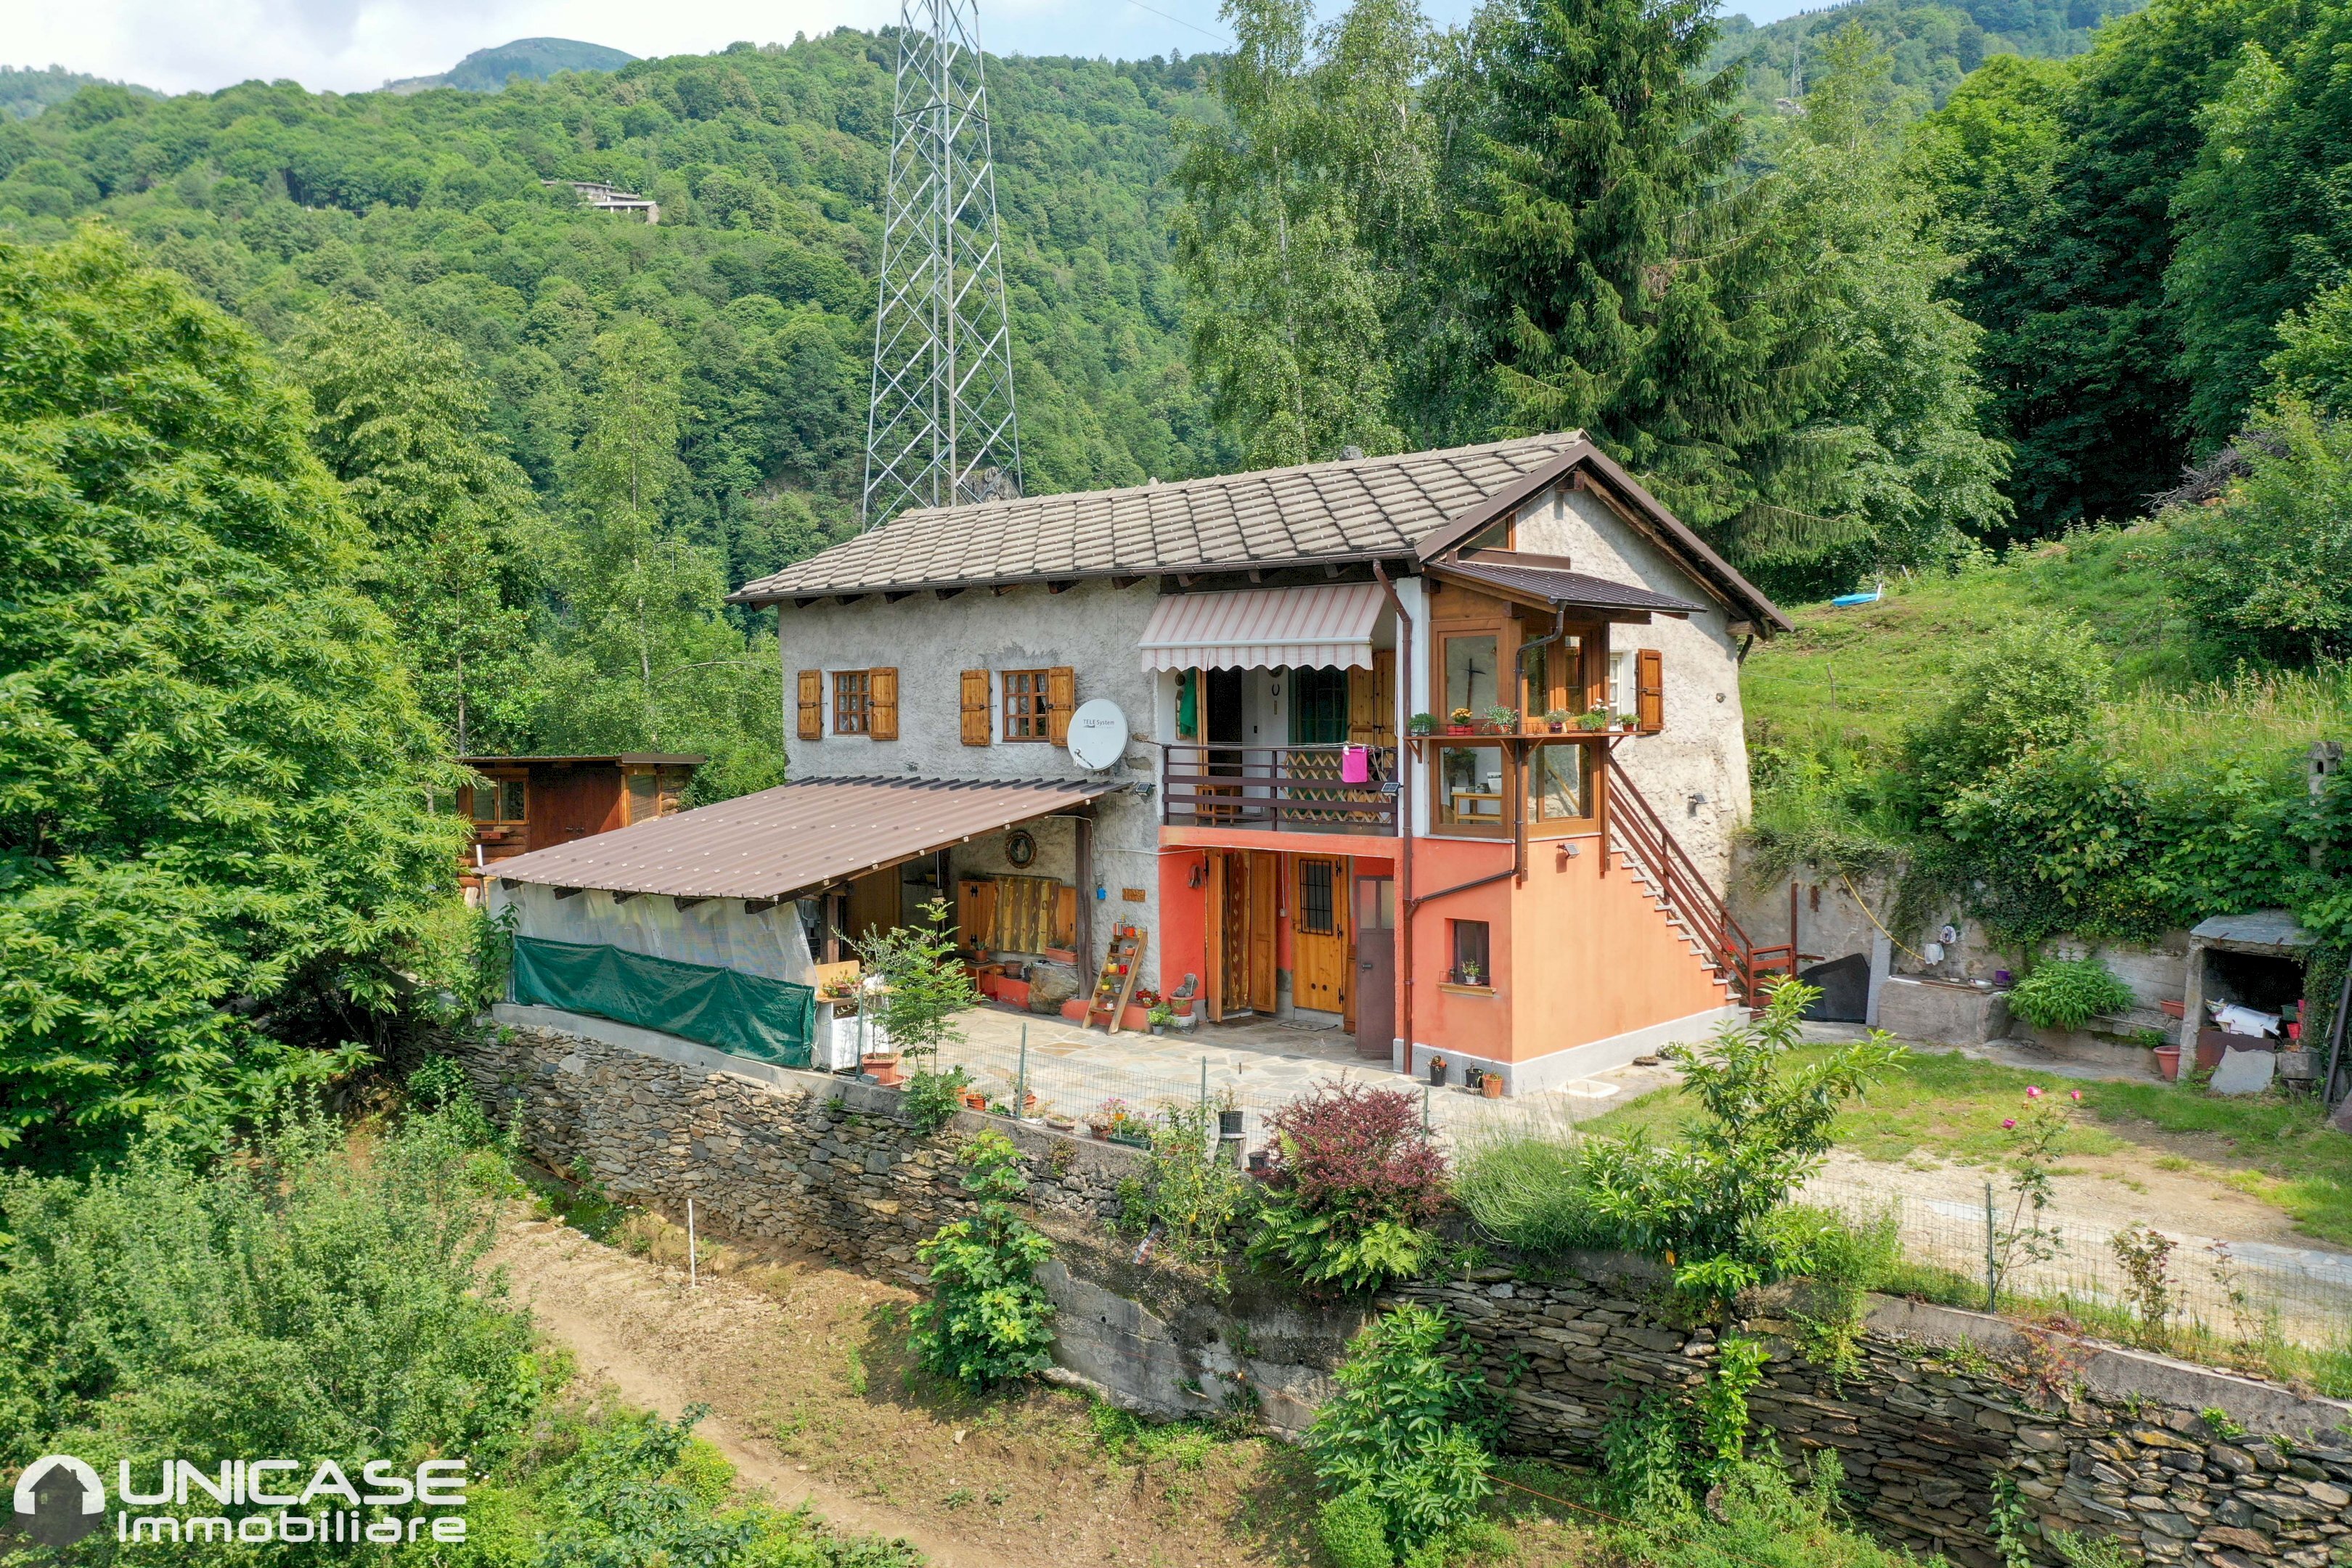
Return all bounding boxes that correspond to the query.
[1510,837,1726,1063]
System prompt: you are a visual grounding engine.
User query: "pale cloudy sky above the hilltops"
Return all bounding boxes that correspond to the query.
[0,0,1800,91]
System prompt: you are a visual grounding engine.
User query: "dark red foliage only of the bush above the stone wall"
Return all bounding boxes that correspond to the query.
[1265,1084,1447,1227]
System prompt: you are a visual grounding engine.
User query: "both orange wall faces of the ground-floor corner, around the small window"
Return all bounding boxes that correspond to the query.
[1413,837,1724,1063]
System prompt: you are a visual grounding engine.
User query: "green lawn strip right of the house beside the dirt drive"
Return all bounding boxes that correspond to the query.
[1583,1048,2352,1246]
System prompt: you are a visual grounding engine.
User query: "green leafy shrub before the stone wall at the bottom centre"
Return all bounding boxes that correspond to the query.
[1305,1307,1496,1564]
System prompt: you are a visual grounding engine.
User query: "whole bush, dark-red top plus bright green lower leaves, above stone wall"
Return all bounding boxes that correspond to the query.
[1249,1084,1447,1291]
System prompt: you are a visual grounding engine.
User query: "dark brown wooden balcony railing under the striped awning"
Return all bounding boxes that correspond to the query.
[1159,740,1397,837]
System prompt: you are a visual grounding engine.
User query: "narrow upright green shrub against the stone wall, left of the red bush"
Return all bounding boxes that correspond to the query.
[910,1133,1054,1394]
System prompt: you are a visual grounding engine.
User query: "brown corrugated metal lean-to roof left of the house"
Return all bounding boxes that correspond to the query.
[489,778,1124,898]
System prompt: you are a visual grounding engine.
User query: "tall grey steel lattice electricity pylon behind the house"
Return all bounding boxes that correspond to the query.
[861,0,1021,526]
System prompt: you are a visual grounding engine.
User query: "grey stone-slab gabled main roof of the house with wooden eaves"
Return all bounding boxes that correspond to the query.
[729,430,1790,634]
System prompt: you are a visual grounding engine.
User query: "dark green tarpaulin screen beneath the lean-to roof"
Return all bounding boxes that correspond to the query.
[515,936,816,1067]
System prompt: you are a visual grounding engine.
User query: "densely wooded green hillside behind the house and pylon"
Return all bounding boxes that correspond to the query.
[0,30,1230,792]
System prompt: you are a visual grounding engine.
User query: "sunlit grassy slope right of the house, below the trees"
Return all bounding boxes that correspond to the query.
[1741,526,2192,750]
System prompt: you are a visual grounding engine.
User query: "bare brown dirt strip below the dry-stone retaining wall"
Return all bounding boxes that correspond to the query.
[494,1217,1307,1568]
